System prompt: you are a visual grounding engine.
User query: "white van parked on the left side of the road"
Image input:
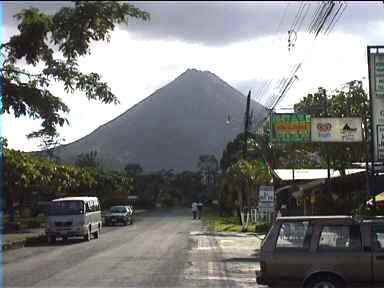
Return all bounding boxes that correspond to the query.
[46,197,102,243]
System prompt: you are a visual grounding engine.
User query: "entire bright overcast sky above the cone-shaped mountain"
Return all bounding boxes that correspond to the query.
[0,1,384,151]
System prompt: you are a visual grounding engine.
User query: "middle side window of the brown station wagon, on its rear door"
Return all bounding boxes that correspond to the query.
[318,225,361,251]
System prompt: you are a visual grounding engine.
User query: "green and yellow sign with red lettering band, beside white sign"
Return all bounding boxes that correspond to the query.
[271,113,311,143]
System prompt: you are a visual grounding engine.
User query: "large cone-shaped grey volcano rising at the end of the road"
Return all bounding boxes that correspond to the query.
[55,69,266,172]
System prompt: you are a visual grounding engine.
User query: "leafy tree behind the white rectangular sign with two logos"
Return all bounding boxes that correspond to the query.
[294,80,369,175]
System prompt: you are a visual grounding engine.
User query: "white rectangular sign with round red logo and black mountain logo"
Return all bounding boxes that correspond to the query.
[311,117,363,142]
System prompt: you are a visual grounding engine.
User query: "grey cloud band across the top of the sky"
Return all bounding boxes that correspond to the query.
[3,1,384,46]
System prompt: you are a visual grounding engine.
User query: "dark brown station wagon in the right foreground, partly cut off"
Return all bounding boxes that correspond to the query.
[256,216,384,288]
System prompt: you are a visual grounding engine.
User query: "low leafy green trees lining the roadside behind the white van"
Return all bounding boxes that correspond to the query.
[3,149,132,213]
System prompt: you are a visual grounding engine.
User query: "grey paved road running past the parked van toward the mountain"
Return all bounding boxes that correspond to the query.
[2,210,255,287]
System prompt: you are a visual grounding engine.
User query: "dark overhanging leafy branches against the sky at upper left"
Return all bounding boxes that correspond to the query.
[0,1,149,137]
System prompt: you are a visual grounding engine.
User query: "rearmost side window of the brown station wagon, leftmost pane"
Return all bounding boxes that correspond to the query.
[276,221,312,249]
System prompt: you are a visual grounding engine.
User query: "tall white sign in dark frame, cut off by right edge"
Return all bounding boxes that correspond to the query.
[368,46,384,161]
